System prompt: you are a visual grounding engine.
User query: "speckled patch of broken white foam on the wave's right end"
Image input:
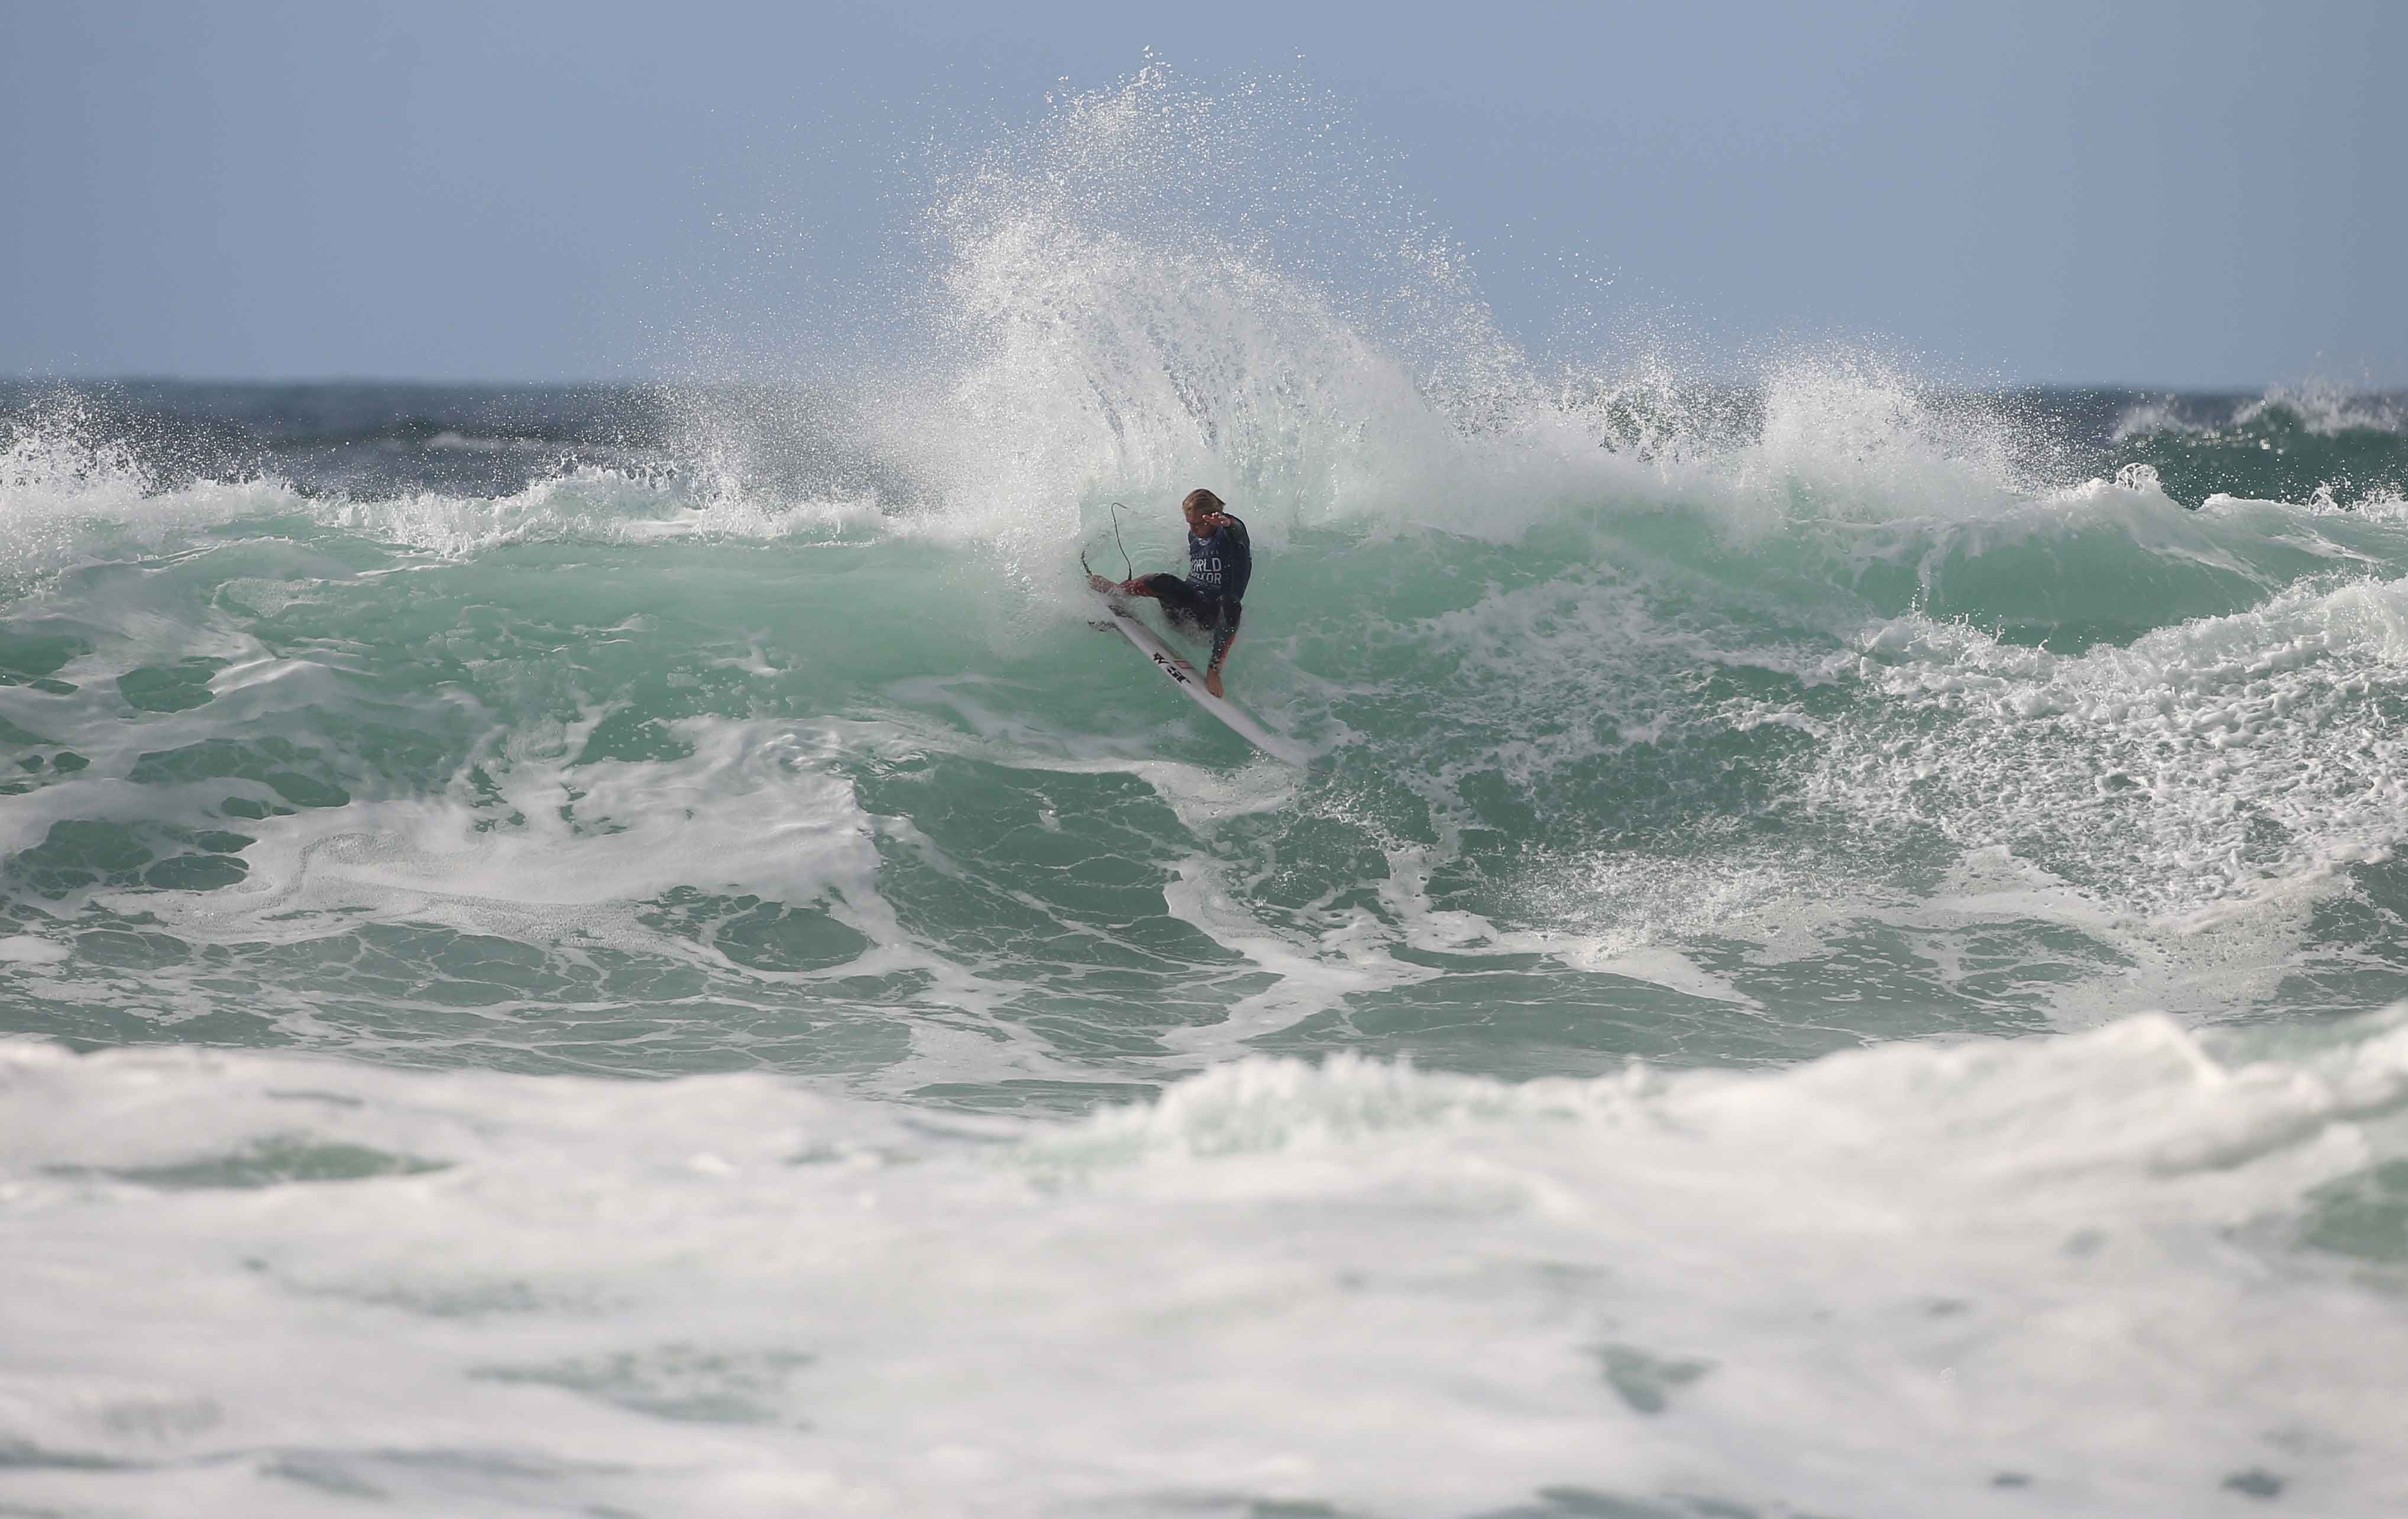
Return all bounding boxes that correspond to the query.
[1815,565,2408,912]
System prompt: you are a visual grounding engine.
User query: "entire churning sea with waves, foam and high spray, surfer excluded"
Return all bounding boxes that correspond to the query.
[0,72,2408,1519]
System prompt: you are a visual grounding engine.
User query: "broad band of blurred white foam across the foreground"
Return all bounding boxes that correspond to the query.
[0,1018,2408,1519]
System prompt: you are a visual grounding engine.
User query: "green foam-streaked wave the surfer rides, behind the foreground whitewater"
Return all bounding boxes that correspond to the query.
[0,373,2408,1107]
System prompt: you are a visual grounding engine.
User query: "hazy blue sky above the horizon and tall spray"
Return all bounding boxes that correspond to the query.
[0,0,2408,387]
